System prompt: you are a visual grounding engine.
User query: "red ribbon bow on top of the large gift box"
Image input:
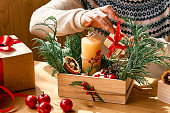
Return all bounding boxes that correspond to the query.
[0,36,21,51]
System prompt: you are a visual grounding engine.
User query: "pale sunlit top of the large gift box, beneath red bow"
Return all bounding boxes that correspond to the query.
[0,35,32,58]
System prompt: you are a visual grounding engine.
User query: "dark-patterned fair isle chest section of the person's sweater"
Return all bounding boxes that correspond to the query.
[81,0,170,38]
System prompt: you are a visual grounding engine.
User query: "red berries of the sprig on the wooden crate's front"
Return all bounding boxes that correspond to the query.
[82,82,96,95]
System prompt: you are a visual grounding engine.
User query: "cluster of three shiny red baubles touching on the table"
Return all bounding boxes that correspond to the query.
[25,92,51,113]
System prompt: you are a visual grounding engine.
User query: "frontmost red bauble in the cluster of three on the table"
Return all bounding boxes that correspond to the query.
[37,102,51,113]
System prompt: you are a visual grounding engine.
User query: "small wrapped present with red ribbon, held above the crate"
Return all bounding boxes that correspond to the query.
[104,19,127,58]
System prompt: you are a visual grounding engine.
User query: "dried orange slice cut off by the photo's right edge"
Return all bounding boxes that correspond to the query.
[161,69,170,85]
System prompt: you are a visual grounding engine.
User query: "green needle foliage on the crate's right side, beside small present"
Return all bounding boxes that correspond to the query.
[118,17,170,85]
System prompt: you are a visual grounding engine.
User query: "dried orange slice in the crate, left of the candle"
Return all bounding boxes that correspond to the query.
[64,56,80,74]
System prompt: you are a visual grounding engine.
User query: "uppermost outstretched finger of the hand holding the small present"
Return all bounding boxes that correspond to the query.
[100,5,119,20]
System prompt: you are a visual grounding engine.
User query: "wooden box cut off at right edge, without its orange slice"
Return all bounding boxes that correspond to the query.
[157,80,170,104]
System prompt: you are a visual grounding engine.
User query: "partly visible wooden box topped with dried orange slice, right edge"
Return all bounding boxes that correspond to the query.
[157,70,170,104]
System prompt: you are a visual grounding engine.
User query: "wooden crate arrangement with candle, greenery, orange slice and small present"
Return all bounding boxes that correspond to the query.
[34,17,170,104]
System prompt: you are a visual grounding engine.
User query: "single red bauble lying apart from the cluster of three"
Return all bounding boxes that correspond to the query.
[60,99,73,112]
